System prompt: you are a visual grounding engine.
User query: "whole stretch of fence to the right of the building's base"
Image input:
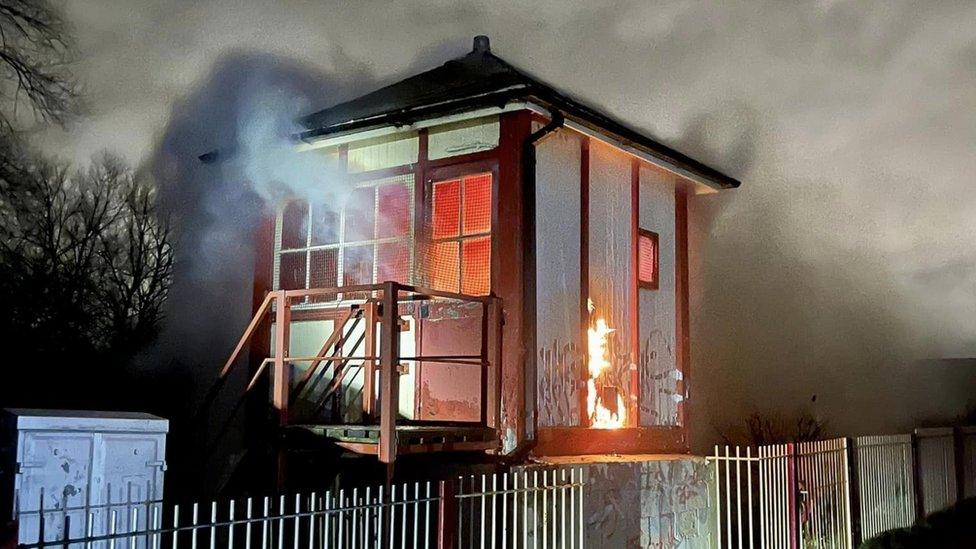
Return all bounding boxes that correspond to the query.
[708,427,976,549]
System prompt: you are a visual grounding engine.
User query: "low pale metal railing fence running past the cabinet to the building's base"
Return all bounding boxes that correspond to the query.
[16,469,585,549]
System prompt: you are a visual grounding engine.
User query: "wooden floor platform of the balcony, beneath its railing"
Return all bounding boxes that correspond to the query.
[282,424,499,455]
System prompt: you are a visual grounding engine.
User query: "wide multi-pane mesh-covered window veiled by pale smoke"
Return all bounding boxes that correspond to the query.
[274,174,414,302]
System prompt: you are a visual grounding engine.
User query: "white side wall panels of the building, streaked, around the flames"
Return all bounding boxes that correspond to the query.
[536,130,681,427]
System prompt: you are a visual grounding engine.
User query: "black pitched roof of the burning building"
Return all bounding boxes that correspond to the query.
[301,36,739,188]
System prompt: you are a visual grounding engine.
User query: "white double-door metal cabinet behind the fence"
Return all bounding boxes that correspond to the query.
[3,409,169,543]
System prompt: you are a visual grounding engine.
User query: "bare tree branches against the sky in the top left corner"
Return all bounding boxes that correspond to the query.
[0,0,77,130]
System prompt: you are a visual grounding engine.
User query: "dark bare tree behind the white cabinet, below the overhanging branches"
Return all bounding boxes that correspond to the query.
[0,141,173,374]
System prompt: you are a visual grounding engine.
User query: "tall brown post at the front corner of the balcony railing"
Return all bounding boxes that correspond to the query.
[379,282,400,464]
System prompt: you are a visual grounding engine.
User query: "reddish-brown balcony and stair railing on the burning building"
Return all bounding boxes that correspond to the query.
[208,282,502,463]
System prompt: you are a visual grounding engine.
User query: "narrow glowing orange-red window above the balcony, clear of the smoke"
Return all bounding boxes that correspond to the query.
[427,173,492,295]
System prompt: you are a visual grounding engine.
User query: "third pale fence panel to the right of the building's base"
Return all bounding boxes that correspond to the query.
[854,435,916,539]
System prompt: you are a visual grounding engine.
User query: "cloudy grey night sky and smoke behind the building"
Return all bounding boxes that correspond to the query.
[35,0,976,446]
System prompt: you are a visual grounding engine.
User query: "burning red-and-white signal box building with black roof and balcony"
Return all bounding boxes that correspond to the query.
[210,37,739,488]
